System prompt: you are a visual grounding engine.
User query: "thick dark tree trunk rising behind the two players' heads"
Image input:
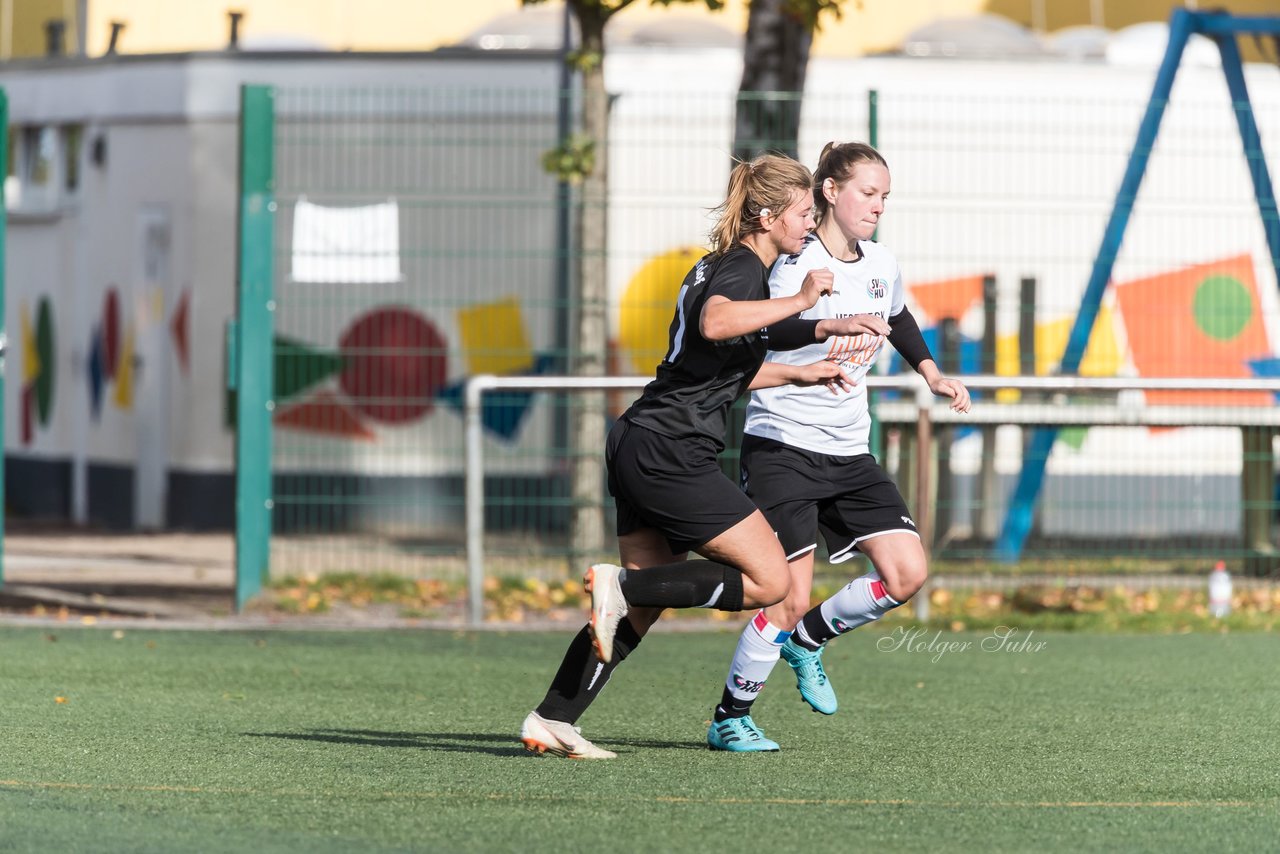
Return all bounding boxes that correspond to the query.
[733,0,813,160]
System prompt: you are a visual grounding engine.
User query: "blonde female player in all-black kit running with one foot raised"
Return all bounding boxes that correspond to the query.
[521,155,888,758]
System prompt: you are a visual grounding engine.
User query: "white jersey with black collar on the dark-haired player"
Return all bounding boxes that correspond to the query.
[745,234,906,457]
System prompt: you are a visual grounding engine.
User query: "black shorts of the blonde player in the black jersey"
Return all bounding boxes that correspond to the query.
[604,419,755,554]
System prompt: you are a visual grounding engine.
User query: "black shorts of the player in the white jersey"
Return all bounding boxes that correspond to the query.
[742,434,916,563]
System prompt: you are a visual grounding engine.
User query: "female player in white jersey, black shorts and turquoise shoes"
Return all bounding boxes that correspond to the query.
[707,142,969,752]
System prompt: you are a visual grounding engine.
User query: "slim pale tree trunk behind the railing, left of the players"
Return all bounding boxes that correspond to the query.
[568,11,609,568]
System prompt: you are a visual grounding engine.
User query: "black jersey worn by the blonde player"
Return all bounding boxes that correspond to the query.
[622,246,769,449]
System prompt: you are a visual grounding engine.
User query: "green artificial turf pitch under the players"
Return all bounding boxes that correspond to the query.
[0,627,1280,854]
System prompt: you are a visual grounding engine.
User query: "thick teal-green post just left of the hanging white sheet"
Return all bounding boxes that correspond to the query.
[233,86,275,611]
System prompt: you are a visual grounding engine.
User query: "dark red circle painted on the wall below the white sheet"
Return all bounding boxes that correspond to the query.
[338,307,447,424]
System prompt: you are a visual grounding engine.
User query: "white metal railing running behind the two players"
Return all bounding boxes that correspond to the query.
[463,374,1280,627]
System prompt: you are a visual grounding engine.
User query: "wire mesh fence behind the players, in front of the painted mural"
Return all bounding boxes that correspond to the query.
[240,68,1280,594]
